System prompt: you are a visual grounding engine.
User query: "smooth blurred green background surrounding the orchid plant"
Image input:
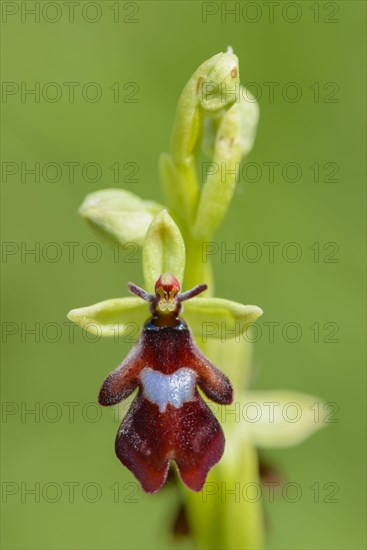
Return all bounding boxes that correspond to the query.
[1,1,366,549]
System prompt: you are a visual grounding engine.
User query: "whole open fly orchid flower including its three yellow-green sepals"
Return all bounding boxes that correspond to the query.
[68,210,262,493]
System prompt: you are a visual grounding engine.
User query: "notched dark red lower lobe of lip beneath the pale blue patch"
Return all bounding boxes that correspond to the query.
[116,391,224,493]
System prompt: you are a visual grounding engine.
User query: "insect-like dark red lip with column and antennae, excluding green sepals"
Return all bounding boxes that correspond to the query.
[99,273,233,493]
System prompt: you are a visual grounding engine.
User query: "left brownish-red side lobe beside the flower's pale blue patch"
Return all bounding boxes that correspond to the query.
[98,348,144,405]
